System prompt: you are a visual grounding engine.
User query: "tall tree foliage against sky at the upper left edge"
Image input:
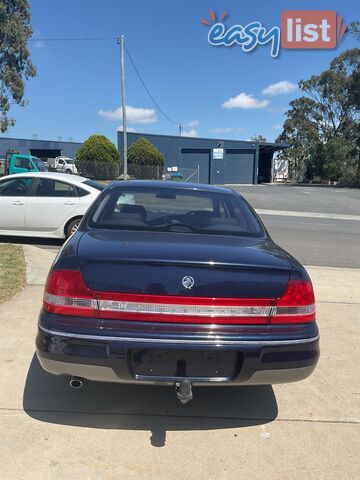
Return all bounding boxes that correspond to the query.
[0,0,36,133]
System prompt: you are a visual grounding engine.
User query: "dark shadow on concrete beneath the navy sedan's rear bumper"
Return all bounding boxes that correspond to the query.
[23,355,278,447]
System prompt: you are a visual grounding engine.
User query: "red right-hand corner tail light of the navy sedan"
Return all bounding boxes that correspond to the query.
[271,280,316,323]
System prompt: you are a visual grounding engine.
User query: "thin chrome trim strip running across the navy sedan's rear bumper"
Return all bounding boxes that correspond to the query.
[39,325,320,346]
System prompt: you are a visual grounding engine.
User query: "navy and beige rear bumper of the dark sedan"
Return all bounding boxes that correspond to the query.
[36,312,319,385]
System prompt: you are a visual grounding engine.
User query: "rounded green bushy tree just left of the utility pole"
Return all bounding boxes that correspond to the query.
[75,135,121,180]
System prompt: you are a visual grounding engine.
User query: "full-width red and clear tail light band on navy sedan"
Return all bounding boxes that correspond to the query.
[43,270,315,324]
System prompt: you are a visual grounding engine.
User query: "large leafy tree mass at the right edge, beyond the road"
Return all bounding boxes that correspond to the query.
[277,48,360,182]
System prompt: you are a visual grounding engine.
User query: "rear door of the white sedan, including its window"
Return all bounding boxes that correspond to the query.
[26,177,79,233]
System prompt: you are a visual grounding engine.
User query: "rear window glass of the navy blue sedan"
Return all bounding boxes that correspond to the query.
[89,187,264,236]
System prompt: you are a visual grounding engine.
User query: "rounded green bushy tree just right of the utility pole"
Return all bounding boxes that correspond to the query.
[128,138,164,178]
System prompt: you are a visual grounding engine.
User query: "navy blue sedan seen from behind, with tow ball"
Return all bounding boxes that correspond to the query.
[36,181,319,403]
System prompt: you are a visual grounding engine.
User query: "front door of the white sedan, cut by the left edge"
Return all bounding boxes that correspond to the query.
[0,176,32,234]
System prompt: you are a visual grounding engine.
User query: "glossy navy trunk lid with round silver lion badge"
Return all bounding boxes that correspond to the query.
[78,230,291,299]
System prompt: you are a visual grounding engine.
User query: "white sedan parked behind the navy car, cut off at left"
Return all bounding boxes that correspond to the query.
[0,172,105,238]
